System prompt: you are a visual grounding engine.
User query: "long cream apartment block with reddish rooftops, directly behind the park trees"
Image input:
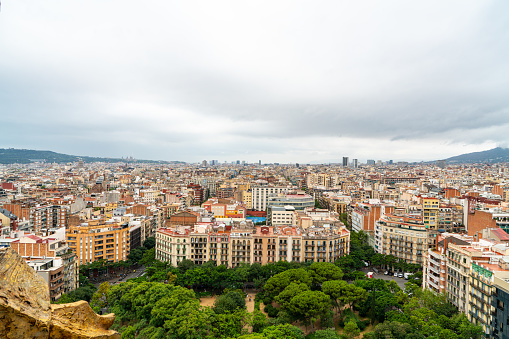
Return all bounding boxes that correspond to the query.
[156,223,350,267]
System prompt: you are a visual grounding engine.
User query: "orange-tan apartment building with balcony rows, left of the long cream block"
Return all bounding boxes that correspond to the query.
[67,219,130,265]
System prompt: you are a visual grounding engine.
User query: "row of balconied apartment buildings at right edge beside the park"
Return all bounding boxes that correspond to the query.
[423,234,509,338]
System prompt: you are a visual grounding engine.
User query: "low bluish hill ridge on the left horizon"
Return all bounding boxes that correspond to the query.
[0,148,179,164]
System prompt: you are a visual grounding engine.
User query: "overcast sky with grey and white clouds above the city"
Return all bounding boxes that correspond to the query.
[0,0,509,163]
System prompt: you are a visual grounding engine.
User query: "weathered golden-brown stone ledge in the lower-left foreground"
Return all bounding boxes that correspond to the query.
[0,248,120,339]
